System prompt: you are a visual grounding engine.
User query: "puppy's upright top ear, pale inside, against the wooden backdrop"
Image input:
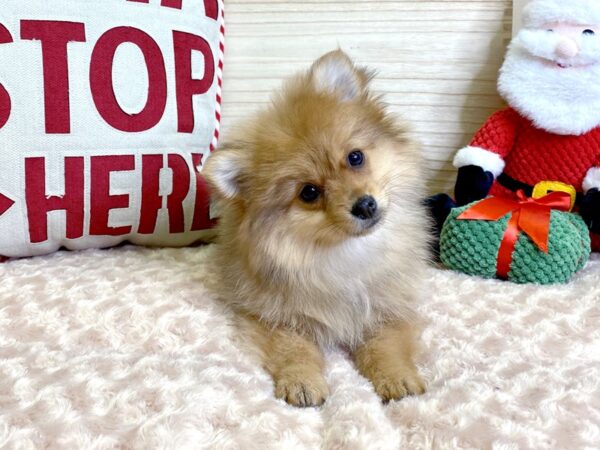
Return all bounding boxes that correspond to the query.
[309,50,371,101]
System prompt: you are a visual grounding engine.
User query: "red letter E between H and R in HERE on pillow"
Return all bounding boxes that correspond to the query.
[90,155,135,236]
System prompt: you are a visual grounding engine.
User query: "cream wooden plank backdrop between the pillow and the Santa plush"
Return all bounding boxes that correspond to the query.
[222,0,512,192]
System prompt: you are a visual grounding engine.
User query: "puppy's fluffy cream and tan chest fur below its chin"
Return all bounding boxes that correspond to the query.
[213,206,422,347]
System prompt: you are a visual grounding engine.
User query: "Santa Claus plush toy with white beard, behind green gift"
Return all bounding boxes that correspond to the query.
[431,0,600,251]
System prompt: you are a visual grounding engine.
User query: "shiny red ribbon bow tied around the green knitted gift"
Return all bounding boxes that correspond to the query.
[458,191,571,279]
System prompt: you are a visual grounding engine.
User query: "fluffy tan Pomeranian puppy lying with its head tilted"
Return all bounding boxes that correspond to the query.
[203,50,428,406]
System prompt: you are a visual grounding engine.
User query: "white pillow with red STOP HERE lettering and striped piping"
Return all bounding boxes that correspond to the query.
[0,0,224,257]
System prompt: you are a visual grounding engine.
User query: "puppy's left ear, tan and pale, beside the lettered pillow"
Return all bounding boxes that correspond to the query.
[202,145,248,198]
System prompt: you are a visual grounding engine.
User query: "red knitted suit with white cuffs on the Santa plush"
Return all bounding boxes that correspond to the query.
[455,108,600,251]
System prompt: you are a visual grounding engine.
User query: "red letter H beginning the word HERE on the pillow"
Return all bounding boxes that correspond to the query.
[25,157,84,243]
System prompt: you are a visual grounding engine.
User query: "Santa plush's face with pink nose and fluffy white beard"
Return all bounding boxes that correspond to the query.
[498,23,600,135]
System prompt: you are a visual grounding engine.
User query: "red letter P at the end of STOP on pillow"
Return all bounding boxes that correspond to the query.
[173,31,215,133]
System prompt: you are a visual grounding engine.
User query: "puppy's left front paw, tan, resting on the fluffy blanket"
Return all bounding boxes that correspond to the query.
[274,366,329,407]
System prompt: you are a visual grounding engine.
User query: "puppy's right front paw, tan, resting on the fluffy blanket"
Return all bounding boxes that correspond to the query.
[371,367,425,402]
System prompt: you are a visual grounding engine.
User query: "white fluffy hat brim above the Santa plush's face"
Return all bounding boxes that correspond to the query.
[523,0,600,28]
